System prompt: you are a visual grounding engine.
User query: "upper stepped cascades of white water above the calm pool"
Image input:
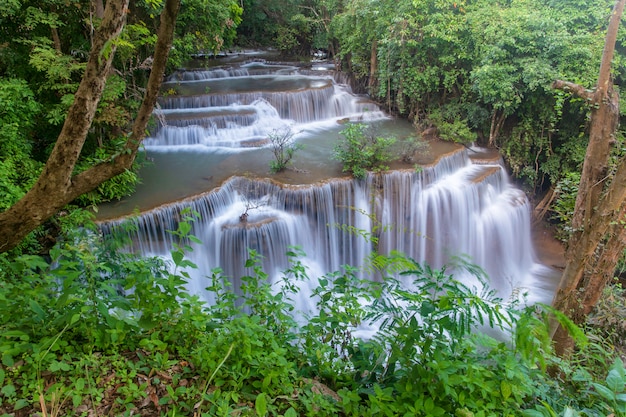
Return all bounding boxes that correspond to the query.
[149,62,387,148]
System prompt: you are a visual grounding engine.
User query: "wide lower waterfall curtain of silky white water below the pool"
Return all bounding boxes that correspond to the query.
[103,150,544,308]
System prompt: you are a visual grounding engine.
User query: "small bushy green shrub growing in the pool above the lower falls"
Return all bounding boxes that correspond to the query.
[334,123,396,179]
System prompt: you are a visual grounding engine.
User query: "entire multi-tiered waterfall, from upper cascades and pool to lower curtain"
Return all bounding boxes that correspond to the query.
[98,53,553,310]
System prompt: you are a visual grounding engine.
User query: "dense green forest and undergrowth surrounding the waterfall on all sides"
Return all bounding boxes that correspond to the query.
[0,0,626,417]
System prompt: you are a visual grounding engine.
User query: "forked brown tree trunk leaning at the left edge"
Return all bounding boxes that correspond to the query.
[0,0,180,252]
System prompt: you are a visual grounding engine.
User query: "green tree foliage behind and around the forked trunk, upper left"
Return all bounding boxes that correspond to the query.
[0,0,242,221]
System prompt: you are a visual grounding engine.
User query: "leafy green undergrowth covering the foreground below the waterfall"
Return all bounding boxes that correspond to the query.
[0,213,626,417]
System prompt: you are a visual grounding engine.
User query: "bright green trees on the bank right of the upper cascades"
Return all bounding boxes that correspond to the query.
[320,0,623,210]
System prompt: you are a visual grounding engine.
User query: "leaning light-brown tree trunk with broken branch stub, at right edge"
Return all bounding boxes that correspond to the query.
[553,0,626,355]
